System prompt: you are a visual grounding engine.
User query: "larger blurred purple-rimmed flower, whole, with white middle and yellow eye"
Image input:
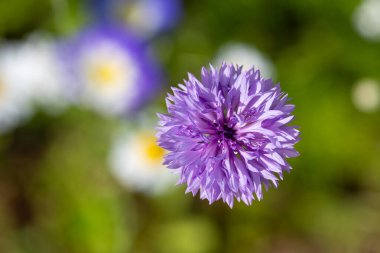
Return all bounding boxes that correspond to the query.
[62,25,162,116]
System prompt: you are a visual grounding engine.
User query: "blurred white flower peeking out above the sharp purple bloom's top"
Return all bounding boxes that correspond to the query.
[213,43,275,78]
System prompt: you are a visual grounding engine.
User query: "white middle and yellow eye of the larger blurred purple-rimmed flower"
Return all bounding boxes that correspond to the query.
[79,40,140,114]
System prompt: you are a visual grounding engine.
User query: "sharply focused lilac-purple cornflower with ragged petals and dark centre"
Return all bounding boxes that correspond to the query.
[157,64,299,208]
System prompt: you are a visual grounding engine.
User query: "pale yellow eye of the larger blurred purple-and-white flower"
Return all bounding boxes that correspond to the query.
[89,62,122,87]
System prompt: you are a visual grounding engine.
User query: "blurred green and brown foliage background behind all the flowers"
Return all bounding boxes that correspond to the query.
[0,0,380,253]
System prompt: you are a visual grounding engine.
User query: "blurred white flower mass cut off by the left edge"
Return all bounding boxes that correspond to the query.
[0,34,66,133]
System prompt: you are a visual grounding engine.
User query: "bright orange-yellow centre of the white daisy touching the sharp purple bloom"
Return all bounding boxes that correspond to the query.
[139,134,165,164]
